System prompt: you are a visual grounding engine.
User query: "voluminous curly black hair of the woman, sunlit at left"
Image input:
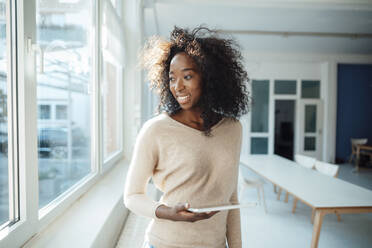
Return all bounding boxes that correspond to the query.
[141,27,249,136]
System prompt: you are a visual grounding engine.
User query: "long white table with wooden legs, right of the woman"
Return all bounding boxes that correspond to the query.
[240,155,372,248]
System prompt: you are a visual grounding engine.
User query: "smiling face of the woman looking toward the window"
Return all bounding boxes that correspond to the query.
[169,53,202,110]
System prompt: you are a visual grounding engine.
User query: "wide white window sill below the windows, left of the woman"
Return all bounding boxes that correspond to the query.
[23,160,128,248]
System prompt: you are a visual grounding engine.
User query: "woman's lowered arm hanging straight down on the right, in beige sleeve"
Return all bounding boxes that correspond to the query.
[226,189,242,248]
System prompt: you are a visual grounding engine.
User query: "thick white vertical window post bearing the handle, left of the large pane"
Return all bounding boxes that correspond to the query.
[16,0,39,227]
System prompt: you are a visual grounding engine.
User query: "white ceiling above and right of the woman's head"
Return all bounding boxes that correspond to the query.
[144,0,372,54]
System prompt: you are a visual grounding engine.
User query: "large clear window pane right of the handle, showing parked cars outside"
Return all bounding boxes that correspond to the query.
[36,0,93,207]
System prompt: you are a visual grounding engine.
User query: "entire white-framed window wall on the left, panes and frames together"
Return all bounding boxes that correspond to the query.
[0,0,124,247]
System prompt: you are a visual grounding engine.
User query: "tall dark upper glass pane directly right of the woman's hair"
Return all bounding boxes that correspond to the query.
[251,80,269,132]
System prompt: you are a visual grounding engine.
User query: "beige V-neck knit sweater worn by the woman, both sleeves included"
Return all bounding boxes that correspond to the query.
[124,113,242,248]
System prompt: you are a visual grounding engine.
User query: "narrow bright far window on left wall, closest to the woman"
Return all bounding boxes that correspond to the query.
[101,1,125,164]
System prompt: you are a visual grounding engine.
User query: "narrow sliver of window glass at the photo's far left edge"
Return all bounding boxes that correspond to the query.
[0,0,9,226]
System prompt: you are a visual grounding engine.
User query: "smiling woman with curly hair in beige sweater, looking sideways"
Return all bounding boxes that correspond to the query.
[124,27,248,248]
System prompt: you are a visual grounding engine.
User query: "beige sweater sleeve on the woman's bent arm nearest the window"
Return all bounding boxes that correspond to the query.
[124,123,161,219]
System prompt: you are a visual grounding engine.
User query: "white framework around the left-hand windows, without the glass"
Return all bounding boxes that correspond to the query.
[0,0,124,247]
